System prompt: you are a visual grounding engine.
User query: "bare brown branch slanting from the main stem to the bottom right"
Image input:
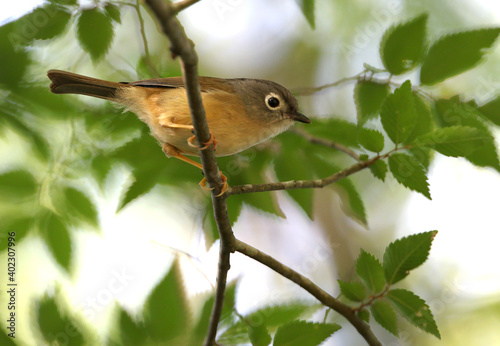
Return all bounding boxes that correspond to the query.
[235,240,382,346]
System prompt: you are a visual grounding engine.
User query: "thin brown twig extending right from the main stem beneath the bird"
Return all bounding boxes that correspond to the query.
[226,154,378,196]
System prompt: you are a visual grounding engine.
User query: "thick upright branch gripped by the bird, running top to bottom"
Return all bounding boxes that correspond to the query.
[142,0,235,346]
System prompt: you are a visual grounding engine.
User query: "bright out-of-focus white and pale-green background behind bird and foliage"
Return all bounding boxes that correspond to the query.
[0,0,500,345]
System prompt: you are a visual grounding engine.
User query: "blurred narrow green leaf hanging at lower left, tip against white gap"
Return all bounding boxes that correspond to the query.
[40,210,72,271]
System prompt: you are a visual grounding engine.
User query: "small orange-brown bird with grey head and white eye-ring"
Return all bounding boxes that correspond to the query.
[47,70,311,192]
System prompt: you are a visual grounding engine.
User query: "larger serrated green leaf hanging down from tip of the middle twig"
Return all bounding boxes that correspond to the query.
[389,153,431,199]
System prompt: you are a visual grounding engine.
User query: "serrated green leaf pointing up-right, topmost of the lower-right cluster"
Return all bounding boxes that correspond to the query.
[384,231,437,285]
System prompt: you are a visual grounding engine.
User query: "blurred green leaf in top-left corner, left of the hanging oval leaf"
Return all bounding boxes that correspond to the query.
[29,4,71,40]
